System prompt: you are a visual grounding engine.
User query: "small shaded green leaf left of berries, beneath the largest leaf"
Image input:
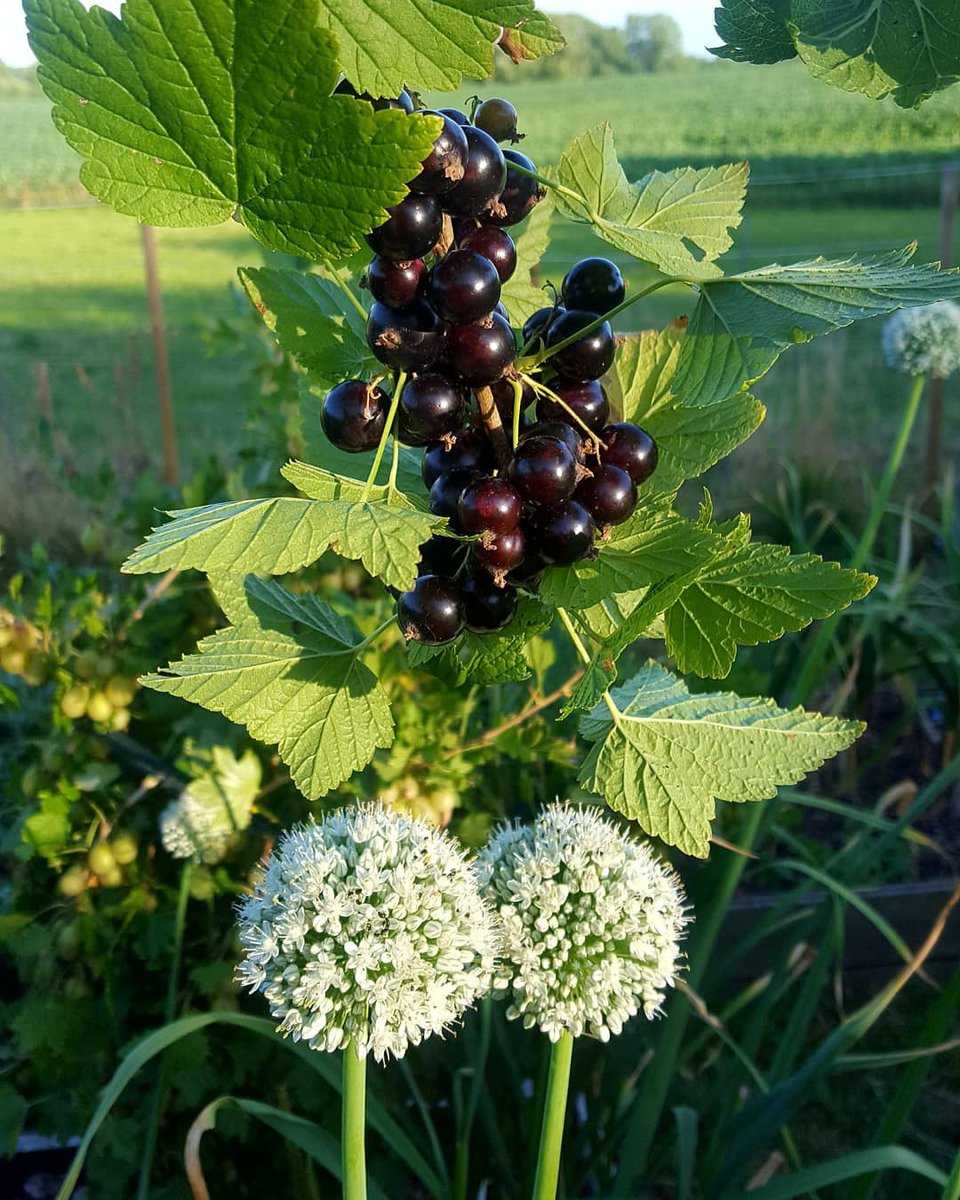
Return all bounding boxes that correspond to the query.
[239,266,379,384]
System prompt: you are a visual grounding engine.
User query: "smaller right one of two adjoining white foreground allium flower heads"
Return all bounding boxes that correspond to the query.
[478,804,688,1042]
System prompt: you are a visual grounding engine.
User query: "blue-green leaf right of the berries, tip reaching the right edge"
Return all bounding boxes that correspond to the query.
[673,246,960,407]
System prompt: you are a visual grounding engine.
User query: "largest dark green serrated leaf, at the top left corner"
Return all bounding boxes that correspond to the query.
[24,0,438,258]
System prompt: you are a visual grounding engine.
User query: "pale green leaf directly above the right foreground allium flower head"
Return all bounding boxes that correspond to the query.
[580,662,864,858]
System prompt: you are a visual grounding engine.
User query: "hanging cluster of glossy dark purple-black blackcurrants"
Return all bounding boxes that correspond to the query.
[323,92,656,646]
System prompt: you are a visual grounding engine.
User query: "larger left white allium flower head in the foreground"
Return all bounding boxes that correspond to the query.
[236,804,498,1062]
